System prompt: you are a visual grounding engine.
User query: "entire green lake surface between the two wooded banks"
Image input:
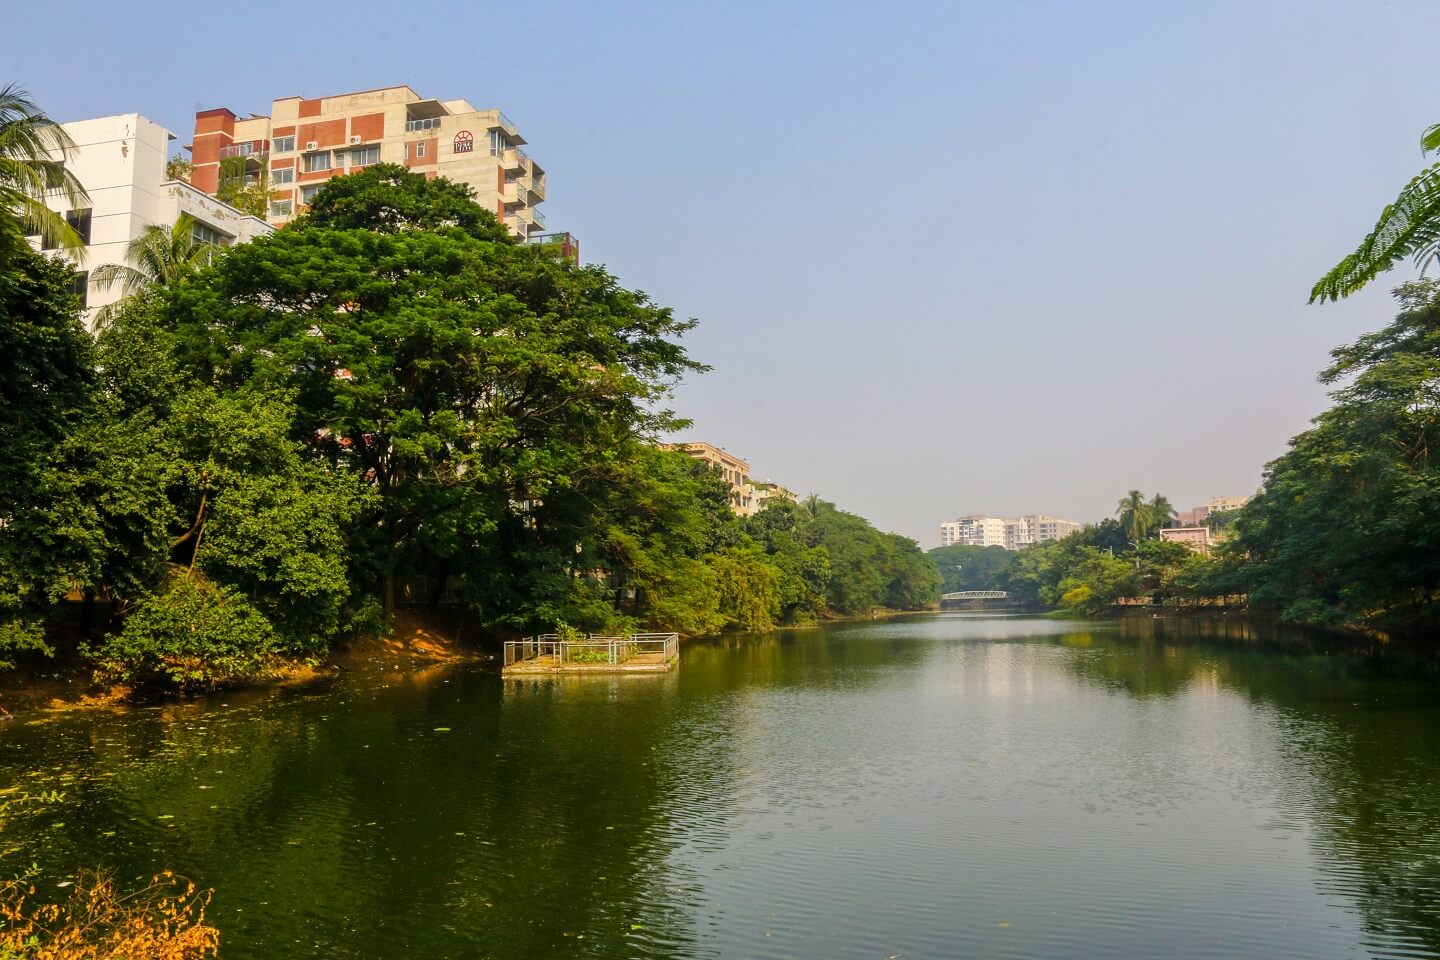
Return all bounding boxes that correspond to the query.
[0,613,1440,960]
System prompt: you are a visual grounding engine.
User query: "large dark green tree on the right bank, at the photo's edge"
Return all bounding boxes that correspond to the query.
[1224,281,1440,632]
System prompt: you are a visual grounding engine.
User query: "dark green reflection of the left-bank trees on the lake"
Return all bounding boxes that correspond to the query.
[6,671,714,957]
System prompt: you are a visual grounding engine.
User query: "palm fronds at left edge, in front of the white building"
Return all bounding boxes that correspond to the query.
[0,83,89,255]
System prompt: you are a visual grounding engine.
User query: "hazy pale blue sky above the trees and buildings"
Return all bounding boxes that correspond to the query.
[0,0,1440,545]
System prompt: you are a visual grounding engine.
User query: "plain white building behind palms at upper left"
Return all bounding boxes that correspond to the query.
[32,114,274,324]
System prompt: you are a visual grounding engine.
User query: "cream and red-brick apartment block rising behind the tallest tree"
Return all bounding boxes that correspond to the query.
[190,85,547,243]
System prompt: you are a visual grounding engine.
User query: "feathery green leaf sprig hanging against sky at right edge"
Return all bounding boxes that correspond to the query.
[1310,124,1440,304]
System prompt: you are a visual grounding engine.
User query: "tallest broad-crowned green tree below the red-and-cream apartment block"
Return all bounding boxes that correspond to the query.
[151,167,701,616]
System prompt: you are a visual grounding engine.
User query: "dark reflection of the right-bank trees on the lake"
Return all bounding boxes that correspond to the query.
[1067,620,1440,956]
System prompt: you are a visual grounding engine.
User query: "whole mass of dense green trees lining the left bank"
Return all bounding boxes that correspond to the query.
[0,166,939,687]
